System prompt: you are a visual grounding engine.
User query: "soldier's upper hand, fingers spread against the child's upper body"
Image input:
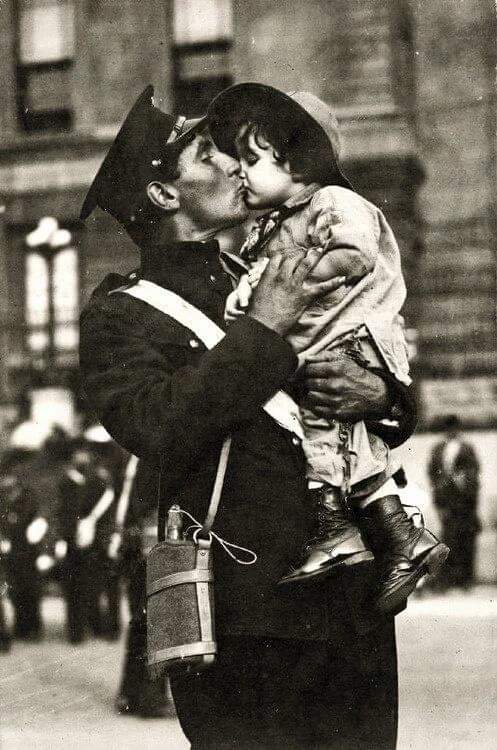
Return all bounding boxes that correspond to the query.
[247,248,345,335]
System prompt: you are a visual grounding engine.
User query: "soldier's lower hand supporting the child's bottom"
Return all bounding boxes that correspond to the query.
[303,348,390,422]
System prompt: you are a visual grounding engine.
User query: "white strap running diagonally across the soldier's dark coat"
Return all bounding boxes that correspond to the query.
[115,279,304,440]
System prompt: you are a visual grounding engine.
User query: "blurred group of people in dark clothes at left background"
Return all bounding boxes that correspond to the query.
[0,422,152,651]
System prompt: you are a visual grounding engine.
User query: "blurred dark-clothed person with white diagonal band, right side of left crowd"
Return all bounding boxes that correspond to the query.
[56,440,114,644]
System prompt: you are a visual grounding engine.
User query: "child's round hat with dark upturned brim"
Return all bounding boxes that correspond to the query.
[207,83,354,190]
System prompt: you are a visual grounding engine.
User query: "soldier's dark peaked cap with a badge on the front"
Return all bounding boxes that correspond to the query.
[80,86,205,224]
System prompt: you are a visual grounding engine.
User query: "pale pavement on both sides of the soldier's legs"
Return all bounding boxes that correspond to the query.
[0,586,497,750]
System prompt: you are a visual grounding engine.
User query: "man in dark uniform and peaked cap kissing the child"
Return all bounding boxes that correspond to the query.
[80,88,412,750]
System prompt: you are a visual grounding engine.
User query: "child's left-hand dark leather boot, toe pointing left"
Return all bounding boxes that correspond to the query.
[279,490,374,583]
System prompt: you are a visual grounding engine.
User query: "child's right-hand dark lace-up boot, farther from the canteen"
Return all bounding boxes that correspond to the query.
[359,495,449,614]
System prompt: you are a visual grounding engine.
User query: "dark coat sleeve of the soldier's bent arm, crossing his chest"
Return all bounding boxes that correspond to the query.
[80,295,297,465]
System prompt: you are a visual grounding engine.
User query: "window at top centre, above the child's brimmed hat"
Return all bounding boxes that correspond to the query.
[173,0,233,117]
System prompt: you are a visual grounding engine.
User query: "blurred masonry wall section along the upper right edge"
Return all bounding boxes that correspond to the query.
[411,0,497,388]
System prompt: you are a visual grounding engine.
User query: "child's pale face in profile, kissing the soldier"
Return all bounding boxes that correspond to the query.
[237,126,294,209]
